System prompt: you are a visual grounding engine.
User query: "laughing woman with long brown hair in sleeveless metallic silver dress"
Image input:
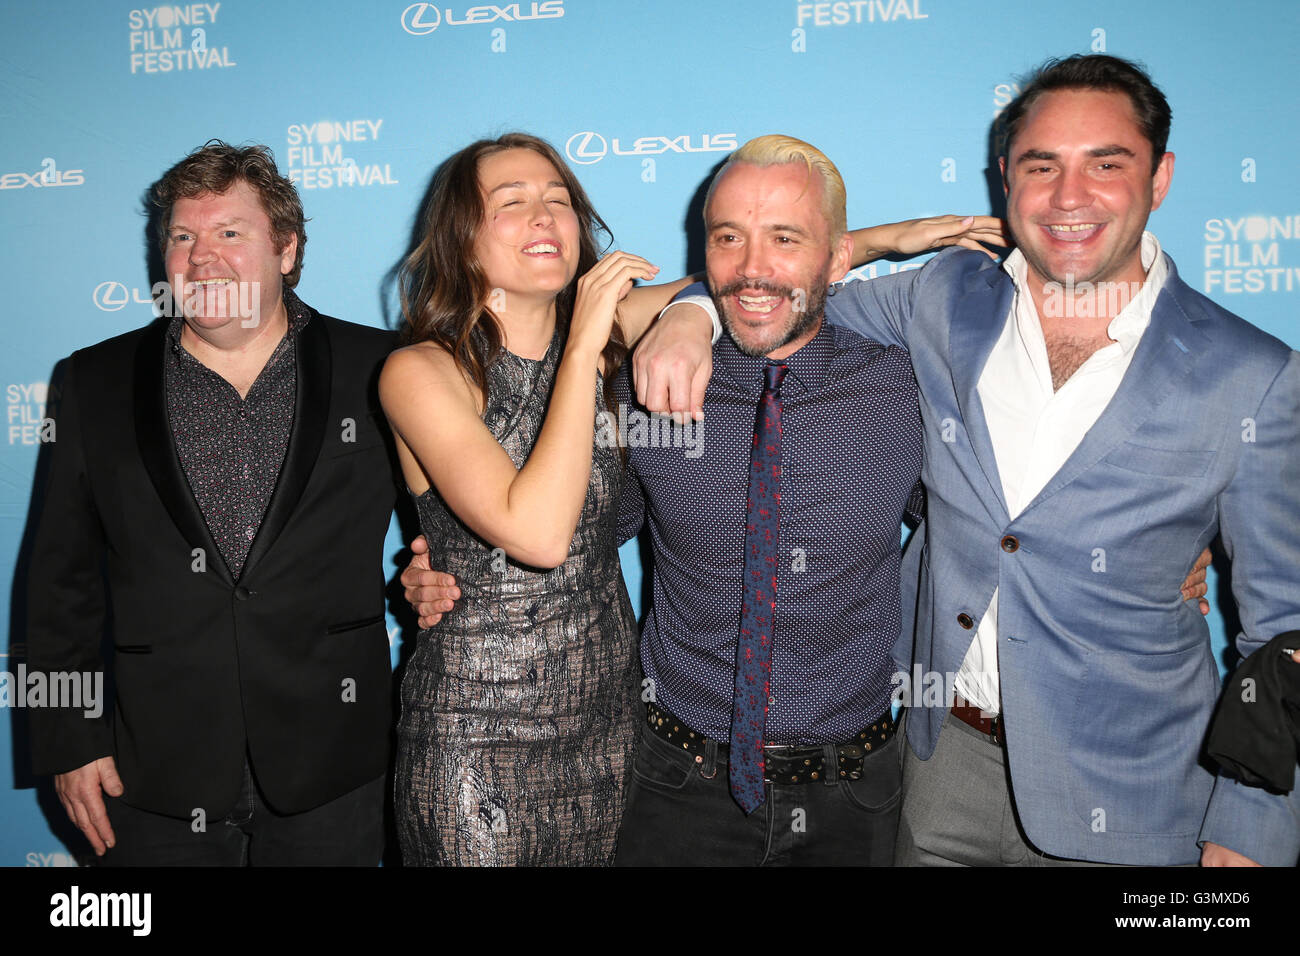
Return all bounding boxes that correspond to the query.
[380,134,684,865]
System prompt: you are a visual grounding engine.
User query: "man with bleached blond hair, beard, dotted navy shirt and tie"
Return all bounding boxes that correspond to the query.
[616,135,925,865]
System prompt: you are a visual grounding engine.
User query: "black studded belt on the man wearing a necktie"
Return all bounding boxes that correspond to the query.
[646,704,897,784]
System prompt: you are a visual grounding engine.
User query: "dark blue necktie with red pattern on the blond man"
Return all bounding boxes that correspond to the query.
[728,365,788,813]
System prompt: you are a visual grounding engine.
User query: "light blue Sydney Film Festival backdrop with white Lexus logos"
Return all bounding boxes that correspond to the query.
[0,0,1300,866]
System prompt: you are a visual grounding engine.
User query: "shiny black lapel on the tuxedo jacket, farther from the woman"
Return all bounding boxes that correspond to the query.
[135,319,234,584]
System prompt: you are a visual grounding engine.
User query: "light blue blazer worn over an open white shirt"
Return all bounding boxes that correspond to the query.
[827,248,1300,866]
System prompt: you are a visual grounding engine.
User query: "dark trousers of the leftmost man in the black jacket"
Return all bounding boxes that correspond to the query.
[103,762,385,866]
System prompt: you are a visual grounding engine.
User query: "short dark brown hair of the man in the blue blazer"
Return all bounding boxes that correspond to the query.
[997,53,1173,173]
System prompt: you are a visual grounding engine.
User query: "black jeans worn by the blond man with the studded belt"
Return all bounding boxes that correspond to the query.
[614,724,904,866]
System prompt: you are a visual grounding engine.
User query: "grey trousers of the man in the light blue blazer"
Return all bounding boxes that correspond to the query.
[894,714,1108,866]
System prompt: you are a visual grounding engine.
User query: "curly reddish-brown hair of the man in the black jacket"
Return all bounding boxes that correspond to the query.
[152,139,307,289]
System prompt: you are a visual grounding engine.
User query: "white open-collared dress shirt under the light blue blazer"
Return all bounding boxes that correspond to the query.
[956,233,1169,715]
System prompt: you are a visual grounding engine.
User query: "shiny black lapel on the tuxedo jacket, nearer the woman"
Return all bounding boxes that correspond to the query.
[241,311,333,578]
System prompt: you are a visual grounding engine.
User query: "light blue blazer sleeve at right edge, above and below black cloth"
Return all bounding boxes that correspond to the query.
[1200,351,1300,866]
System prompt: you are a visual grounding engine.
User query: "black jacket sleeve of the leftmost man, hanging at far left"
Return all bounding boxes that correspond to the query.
[27,354,113,774]
